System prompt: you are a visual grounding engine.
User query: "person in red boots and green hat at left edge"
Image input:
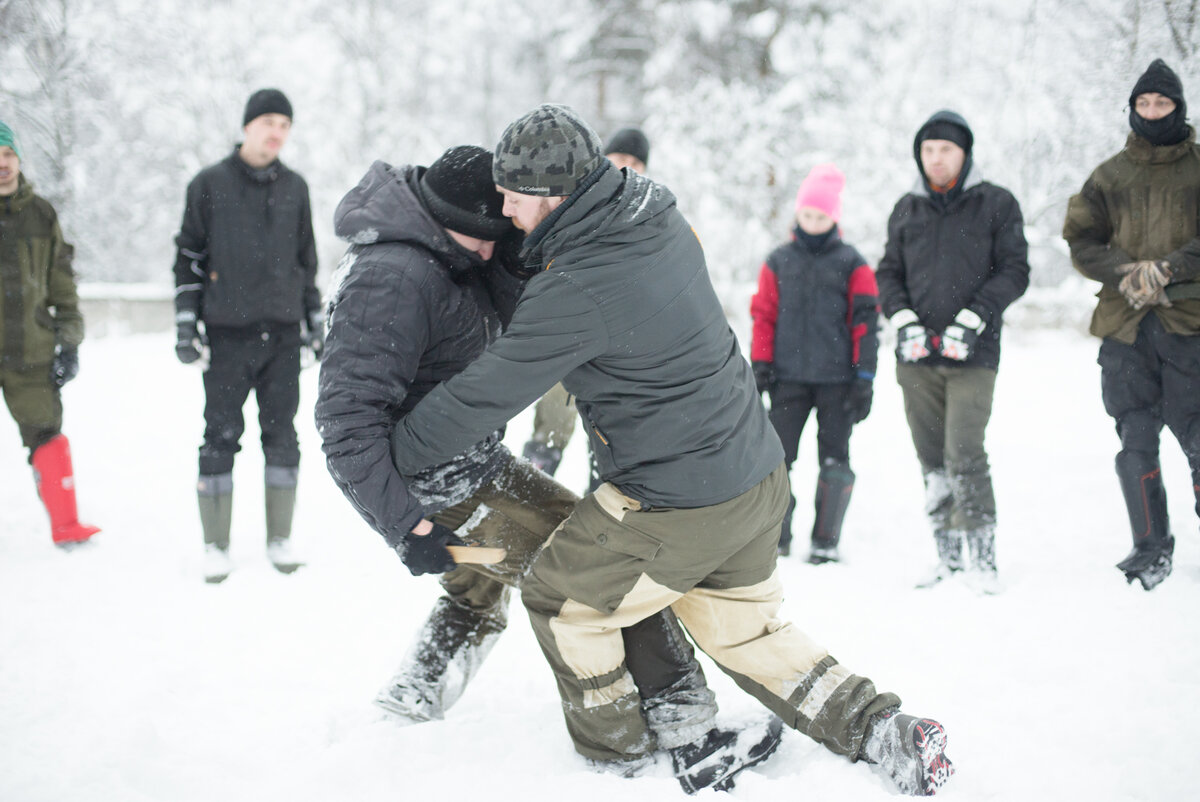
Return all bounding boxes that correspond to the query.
[0,122,100,547]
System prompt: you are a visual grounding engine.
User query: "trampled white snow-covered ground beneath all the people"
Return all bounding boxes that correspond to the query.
[0,327,1200,802]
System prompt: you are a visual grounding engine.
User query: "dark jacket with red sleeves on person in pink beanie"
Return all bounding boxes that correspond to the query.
[750,229,880,384]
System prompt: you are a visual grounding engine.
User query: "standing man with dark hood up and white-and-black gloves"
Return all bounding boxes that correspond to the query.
[876,110,1030,592]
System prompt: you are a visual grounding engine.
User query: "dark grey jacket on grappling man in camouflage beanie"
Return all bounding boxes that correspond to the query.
[394,163,784,507]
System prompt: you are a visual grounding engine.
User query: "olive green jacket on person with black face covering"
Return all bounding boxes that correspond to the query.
[1062,127,1200,343]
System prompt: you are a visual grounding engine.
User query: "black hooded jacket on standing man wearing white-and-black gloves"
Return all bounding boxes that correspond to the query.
[875,166,1030,370]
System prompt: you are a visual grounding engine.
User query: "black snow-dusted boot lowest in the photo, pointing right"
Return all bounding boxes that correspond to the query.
[670,716,784,794]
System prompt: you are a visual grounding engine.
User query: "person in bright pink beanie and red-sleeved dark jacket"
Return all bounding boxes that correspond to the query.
[750,164,880,564]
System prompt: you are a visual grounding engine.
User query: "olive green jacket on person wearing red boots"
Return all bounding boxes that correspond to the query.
[0,176,83,370]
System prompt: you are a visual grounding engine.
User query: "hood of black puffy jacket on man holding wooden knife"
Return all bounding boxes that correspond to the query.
[334,161,482,269]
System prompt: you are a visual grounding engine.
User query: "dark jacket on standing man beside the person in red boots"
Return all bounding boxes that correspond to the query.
[175,150,320,327]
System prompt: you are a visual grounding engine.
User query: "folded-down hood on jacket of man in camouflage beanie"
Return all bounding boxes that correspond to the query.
[526,164,676,267]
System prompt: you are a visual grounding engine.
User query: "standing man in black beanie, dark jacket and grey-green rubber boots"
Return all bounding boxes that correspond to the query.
[174,89,324,582]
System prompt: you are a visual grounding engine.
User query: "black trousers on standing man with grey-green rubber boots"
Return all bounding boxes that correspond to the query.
[200,323,300,475]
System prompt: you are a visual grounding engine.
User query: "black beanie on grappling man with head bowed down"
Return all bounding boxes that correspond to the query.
[418,145,512,241]
